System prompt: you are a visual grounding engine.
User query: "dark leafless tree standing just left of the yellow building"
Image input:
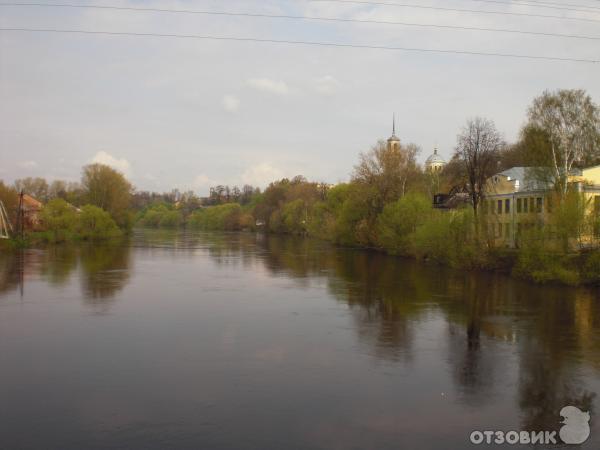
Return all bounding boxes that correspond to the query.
[455,117,503,215]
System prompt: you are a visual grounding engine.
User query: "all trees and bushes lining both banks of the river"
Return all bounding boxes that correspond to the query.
[0,91,600,285]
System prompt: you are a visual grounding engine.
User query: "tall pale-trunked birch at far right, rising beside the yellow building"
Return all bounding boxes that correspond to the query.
[527,90,600,198]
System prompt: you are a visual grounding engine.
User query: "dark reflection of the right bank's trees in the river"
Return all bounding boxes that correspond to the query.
[189,230,600,438]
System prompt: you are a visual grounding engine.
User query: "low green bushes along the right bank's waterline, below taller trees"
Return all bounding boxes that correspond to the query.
[138,192,600,286]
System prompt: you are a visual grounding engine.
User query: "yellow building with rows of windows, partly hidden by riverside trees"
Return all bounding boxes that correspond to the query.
[481,166,600,247]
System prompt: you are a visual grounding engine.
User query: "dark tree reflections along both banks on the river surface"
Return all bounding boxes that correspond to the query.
[0,231,600,436]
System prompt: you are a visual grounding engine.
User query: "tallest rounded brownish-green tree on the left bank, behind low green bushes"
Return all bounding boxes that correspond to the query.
[81,164,133,227]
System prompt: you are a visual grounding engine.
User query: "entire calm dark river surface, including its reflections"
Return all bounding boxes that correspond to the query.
[0,231,600,450]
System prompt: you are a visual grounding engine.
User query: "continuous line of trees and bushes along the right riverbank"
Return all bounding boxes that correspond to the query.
[183,90,600,284]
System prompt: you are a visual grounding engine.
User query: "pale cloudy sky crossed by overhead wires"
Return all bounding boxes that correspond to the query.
[0,0,600,195]
